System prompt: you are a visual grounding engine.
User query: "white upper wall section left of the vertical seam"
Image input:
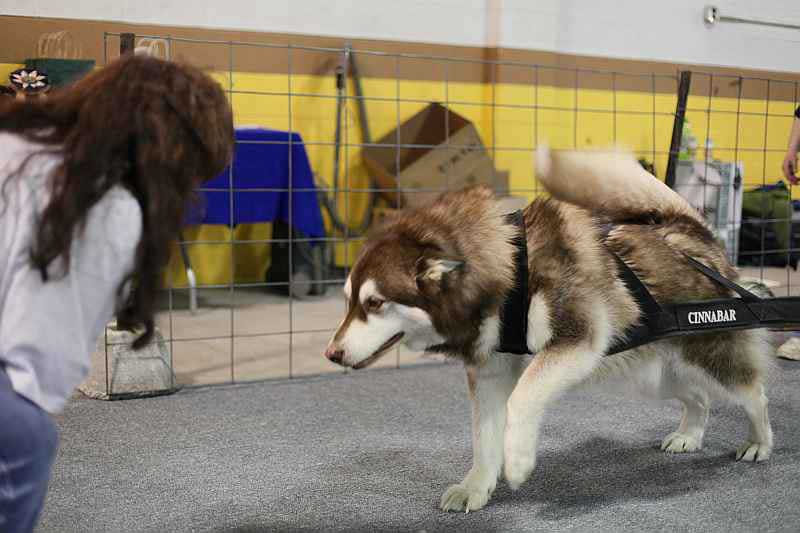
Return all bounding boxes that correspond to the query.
[0,0,486,46]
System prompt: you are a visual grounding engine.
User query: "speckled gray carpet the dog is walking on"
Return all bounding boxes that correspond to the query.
[39,362,800,532]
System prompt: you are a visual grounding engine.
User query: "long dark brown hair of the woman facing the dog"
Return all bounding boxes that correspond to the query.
[0,54,234,348]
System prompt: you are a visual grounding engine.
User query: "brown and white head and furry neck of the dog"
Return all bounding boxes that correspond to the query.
[325,188,511,369]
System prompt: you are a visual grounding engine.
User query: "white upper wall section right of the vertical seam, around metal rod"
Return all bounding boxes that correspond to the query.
[501,0,800,72]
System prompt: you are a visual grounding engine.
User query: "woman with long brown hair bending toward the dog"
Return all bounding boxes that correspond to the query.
[0,55,234,531]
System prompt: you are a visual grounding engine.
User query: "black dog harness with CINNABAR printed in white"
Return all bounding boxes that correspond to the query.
[498,211,800,355]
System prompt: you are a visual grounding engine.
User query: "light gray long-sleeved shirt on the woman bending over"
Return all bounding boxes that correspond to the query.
[0,133,142,413]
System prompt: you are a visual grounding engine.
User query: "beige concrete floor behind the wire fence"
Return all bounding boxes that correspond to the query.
[100,268,800,385]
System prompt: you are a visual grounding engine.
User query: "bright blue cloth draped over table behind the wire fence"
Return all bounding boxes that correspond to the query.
[187,128,325,237]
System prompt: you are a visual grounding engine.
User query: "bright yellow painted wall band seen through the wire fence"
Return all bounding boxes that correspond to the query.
[0,65,800,286]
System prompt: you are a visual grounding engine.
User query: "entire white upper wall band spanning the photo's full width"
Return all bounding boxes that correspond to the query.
[0,0,800,72]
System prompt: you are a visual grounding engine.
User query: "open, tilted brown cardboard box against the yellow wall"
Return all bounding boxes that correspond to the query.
[362,103,508,207]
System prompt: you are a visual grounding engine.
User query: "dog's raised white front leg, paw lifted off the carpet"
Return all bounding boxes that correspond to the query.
[505,342,600,490]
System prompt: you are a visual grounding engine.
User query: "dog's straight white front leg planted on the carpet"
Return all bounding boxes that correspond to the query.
[441,354,525,512]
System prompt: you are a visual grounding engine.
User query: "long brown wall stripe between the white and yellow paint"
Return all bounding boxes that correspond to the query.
[0,15,800,102]
